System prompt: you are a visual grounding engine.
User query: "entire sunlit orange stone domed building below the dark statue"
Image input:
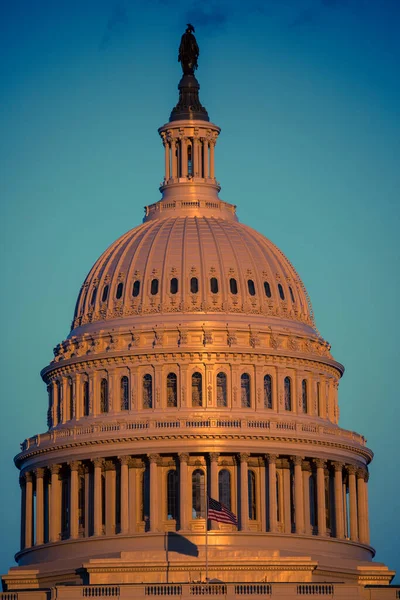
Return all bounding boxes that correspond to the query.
[3,29,399,600]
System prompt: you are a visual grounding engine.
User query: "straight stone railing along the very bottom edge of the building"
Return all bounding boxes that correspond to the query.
[11,582,399,600]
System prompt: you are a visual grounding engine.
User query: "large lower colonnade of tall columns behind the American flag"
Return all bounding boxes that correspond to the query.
[20,452,369,549]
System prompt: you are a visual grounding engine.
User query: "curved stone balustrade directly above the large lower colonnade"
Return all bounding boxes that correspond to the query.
[21,416,366,452]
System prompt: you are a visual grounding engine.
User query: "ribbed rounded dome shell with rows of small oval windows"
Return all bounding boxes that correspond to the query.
[73,202,313,333]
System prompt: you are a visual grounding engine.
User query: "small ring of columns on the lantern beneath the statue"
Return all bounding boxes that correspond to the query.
[163,135,216,182]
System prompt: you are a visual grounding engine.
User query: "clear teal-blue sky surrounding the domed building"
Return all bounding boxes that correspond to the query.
[0,0,400,573]
